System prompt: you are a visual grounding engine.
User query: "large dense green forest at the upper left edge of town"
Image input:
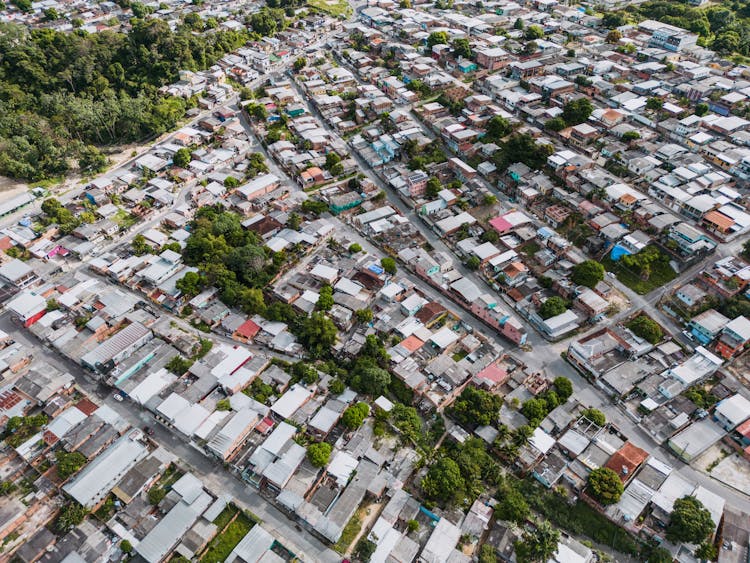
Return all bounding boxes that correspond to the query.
[0,18,248,181]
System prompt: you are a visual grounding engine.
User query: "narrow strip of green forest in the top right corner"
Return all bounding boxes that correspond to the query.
[603,0,750,57]
